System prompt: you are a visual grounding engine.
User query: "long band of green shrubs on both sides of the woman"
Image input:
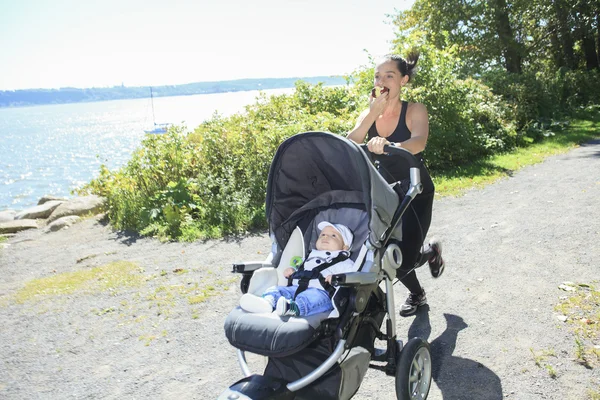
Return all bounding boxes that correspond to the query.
[80,53,600,241]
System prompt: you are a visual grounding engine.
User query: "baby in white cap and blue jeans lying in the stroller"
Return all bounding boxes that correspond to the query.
[240,221,355,317]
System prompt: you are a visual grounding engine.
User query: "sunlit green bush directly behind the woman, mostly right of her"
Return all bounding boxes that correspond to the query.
[353,46,516,170]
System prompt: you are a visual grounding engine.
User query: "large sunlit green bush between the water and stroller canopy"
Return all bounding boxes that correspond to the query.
[81,82,356,241]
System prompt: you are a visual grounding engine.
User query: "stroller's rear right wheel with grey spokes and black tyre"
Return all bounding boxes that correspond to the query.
[396,338,431,400]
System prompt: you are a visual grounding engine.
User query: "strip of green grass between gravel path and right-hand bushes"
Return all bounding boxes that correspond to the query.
[434,113,600,197]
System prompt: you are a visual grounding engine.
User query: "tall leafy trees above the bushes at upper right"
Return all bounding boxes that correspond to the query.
[394,0,600,76]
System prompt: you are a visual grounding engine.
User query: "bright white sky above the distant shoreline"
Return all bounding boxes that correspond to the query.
[0,0,414,90]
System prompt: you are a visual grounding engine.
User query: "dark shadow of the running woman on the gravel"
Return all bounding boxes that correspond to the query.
[408,306,503,400]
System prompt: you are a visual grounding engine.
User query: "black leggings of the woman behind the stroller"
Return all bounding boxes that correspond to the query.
[396,191,435,294]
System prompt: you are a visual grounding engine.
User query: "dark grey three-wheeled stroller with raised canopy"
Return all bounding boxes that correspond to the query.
[219,132,432,400]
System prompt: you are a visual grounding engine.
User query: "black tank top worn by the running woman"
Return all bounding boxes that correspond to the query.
[367,101,435,194]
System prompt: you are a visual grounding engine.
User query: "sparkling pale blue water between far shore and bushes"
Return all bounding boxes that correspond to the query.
[0,89,294,211]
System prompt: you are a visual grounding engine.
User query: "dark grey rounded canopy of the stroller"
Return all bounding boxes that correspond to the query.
[266,132,401,248]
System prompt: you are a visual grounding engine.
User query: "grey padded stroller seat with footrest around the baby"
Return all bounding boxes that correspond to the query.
[225,198,368,357]
